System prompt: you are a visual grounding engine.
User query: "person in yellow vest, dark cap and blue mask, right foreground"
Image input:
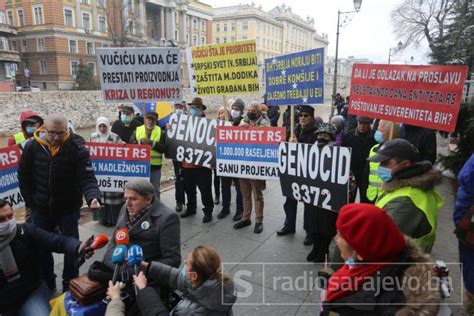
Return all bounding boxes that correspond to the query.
[369,138,444,253]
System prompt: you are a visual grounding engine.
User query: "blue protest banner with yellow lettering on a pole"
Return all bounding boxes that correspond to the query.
[265,48,324,106]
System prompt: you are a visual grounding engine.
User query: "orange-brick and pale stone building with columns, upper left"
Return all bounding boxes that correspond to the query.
[5,0,212,90]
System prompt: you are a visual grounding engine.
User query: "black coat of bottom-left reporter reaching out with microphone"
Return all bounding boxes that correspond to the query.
[0,224,81,313]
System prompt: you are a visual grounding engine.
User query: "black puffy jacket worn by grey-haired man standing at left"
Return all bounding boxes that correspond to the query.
[18,134,100,216]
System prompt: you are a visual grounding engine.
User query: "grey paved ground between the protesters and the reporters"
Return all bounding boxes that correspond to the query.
[55,123,470,315]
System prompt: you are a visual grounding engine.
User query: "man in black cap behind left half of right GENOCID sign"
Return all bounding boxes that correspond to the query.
[277,105,319,245]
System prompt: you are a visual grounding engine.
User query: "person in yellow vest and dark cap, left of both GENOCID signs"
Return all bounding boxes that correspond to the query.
[130,112,166,199]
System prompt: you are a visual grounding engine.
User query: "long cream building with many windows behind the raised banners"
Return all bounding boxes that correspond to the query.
[212,3,329,89]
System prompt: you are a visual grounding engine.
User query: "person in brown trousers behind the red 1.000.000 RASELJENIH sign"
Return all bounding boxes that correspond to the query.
[234,102,270,234]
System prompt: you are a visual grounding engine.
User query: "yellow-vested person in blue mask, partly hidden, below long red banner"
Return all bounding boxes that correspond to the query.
[367,120,400,204]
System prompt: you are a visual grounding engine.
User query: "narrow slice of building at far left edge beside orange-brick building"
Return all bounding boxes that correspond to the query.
[0,0,20,92]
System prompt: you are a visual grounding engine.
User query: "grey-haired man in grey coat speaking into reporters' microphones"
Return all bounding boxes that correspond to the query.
[104,180,181,268]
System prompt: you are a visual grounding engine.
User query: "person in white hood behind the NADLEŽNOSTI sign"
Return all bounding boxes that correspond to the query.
[91,116,123,227]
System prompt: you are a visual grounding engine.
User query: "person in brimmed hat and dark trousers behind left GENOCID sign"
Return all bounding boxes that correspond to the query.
[181,98,214,223]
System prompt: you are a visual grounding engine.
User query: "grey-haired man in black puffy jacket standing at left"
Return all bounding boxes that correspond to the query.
[18,113,100,291]
